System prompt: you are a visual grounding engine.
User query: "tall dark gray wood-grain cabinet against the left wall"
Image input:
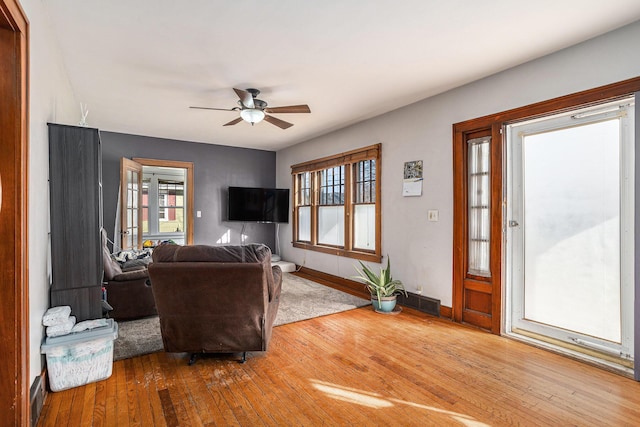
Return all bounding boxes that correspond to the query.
[49,123,103,321]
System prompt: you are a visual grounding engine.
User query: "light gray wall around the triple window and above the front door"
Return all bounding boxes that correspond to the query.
[276,21,640,307]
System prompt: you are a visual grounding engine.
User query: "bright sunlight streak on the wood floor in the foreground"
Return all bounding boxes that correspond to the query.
[311,380,488,427]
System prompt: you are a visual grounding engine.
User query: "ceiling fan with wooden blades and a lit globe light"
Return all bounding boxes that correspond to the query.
[189,88,311,129]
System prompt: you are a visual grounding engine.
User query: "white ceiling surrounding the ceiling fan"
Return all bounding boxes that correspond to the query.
[43,0,640,150]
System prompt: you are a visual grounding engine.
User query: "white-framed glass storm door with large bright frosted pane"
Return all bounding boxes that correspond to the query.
[505,98,634,369]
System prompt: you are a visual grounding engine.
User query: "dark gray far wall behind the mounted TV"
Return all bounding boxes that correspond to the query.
[100,131,276,250]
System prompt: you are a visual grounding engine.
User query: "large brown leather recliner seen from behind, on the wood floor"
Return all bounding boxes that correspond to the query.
[149,244,282,364]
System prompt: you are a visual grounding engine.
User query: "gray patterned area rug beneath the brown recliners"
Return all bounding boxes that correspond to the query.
[113,273,371,360]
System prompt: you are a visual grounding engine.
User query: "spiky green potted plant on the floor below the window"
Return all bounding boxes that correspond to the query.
[355,257,408,313]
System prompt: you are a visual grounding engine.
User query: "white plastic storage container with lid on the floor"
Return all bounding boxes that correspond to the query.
[40,319,118,391]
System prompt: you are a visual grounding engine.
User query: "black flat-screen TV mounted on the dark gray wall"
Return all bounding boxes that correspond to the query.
[228,187,289,222]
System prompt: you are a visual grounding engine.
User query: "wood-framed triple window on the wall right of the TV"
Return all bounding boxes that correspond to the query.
[291,144,381,262]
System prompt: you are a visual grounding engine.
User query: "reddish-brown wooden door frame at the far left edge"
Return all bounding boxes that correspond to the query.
[0,0,30,425]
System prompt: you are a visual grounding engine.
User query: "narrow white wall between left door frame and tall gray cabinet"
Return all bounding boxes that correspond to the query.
[20,0,80,382]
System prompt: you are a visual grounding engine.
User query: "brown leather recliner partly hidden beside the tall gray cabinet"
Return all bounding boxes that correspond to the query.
[102,229,157,320]
